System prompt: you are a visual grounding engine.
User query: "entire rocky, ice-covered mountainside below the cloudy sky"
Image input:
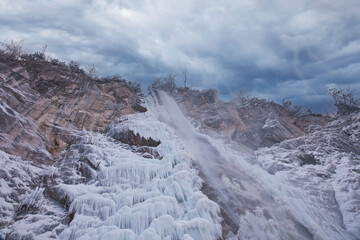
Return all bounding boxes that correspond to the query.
[0,56,360,240]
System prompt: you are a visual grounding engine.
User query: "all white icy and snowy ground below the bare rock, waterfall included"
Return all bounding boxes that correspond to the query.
[0,92,360,240]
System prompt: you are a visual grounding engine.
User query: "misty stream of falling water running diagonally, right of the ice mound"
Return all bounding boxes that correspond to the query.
[149,92,352,239]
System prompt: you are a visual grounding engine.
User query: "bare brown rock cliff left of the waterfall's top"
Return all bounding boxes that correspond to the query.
[0,56,146,163]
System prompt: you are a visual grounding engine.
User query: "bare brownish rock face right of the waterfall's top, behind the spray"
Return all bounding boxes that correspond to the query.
[168,88,329,150]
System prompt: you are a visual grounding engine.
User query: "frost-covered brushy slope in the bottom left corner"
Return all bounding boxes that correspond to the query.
[0,151,65,239]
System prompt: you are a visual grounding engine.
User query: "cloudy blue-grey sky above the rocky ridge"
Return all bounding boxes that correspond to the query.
[0,0,360,111]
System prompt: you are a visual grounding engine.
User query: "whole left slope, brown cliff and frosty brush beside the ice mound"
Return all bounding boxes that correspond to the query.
[0,54,148,239]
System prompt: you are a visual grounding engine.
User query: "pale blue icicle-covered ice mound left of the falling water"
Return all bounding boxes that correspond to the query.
[57,92,221,240]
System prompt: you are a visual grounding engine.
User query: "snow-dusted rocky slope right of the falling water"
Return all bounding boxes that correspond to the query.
[255,112,360,239]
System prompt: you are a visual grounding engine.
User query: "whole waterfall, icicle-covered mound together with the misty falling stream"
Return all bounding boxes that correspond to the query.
[57,91,354,240]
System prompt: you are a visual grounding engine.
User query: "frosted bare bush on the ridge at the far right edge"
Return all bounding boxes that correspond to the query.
[327,88,360,116]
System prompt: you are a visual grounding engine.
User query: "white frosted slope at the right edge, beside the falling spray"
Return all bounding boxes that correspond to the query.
[256,113,360,239]
